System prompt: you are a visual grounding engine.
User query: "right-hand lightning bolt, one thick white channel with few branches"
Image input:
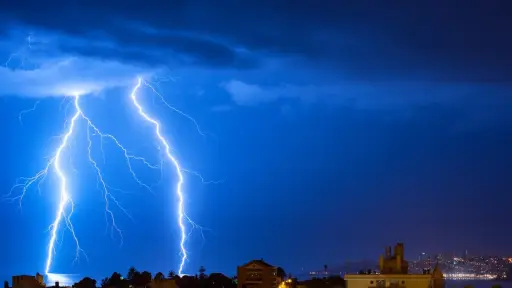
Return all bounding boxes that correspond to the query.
[130,77,190,275]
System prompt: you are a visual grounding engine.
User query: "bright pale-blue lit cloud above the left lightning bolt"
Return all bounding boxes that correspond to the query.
[0,33,162,98]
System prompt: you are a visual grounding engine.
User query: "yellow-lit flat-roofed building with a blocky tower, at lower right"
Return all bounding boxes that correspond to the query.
[344,243,444,288]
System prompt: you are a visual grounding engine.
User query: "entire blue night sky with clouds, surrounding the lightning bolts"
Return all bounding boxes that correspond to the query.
[0,0,512,279]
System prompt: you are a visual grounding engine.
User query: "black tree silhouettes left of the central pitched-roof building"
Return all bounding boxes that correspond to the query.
[73,266,237,288]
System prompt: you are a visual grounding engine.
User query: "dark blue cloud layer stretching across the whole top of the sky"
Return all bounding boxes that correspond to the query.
[0,0,512,82]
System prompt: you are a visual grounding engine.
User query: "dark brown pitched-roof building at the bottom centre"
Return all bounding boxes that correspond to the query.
[237,260,283,288]
